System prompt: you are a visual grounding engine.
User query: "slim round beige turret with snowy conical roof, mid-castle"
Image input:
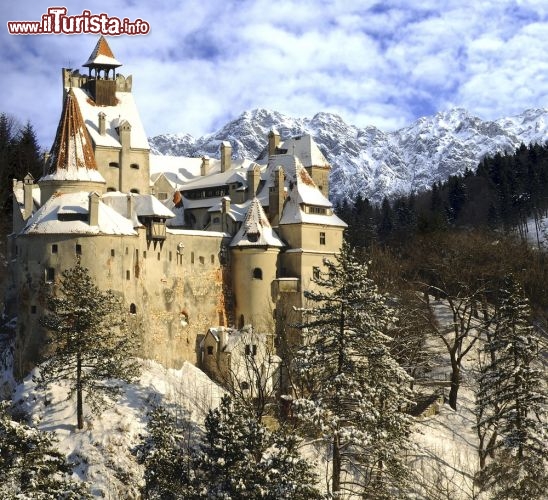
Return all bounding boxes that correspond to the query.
[230,198,284,333]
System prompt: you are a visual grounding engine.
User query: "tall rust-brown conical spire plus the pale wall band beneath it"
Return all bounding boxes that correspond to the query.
[38,89,105,205]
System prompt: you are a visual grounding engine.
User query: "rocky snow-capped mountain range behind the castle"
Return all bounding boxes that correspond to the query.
[150,108,548,202]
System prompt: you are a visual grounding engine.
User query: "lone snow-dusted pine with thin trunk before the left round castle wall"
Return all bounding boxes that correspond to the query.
[38,264,139,429]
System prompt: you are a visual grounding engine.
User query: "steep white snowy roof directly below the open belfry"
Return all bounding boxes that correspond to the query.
[72,88,150,149]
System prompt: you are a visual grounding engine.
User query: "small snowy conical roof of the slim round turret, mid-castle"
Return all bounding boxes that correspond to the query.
[230,198,285,247]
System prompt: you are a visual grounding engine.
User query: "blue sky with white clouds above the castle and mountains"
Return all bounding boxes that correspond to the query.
[0,0,548,148]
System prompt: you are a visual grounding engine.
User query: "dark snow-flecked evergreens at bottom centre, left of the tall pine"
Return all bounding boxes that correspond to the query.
[194,396,320,500]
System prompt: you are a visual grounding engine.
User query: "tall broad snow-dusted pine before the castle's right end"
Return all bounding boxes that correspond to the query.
[294,244,411,498]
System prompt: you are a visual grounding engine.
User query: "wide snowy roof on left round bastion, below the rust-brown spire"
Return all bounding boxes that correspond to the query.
[21,191,137,235]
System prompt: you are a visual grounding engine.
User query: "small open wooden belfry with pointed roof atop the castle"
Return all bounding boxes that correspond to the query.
[84,36,122,106]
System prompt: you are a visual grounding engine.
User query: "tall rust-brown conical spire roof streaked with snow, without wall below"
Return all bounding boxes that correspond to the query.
[41,89,105,182]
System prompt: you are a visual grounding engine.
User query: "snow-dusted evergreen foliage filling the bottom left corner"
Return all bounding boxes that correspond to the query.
[0,402,92,500]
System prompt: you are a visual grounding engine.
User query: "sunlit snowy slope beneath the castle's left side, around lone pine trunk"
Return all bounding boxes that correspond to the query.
[9,361,222,500]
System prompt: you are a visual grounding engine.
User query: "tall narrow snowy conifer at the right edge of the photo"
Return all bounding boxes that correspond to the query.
[476,275,548,499]
